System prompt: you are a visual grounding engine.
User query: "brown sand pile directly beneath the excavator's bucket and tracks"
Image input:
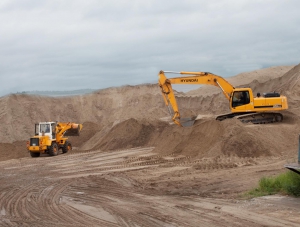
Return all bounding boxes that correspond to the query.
[151,111,300,157]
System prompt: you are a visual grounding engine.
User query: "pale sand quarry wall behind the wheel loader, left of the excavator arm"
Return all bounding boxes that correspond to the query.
[0,85,167,143]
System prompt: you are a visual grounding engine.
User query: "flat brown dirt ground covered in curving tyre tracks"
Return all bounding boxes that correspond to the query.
[0,147,300,227]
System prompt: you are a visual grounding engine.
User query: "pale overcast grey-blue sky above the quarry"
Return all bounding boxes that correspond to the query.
[0,0,300,96]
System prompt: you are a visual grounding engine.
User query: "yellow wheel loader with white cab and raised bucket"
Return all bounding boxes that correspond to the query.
[27,122,82,157]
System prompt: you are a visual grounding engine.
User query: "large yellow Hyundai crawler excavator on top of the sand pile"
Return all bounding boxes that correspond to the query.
[158,71,288,126]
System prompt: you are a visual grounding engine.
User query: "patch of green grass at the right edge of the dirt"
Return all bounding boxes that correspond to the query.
[246,171,300,197]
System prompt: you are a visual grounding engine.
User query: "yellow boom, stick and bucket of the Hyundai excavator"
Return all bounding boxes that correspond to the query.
[158,71,234,126]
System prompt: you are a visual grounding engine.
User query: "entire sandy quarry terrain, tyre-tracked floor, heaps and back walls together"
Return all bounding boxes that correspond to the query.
[0,65,300,226]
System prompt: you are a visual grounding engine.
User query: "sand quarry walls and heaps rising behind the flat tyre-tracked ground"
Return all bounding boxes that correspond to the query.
[0,65,300,160]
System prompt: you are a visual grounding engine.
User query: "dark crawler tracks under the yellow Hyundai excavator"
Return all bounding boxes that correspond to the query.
[216,112,283,124]
